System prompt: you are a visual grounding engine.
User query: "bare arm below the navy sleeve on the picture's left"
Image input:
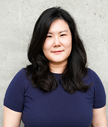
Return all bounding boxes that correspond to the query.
[3,106,22,127]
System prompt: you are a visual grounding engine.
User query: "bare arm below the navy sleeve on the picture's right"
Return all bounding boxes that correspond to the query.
[92,106,107,127]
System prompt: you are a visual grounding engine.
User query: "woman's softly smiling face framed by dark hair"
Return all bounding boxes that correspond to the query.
[43,19,72,64]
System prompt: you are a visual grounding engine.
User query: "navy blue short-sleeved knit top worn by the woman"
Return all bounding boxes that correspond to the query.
[4,69,106,127]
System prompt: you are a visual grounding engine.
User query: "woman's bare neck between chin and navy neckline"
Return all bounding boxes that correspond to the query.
[49,61,67,74]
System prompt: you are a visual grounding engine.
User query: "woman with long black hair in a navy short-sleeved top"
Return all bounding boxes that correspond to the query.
[3,7,107,127]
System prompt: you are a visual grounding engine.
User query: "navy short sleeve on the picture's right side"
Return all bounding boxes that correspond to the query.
[91,71,106,108]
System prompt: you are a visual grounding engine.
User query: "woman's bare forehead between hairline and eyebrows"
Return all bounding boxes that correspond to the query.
[49,19,70,33]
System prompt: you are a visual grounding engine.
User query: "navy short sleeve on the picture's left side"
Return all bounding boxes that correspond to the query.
[4,69,24,112]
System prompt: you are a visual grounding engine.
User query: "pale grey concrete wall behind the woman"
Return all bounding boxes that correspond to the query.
[0,0,108,127]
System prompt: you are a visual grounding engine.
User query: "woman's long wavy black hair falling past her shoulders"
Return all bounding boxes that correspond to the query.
[26,7,90,93]
